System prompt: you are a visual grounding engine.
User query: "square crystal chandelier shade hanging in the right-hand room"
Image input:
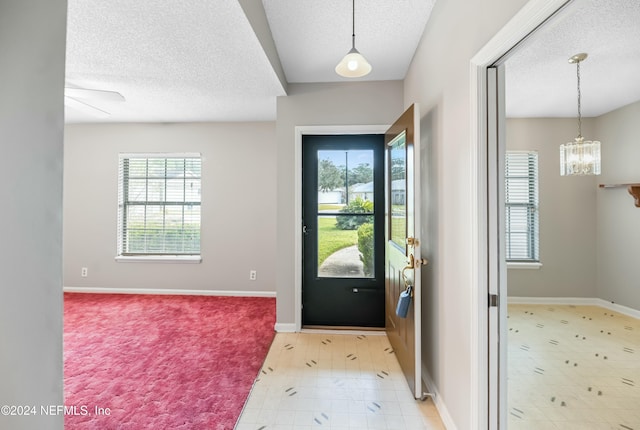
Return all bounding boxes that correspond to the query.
[560,137,600,176]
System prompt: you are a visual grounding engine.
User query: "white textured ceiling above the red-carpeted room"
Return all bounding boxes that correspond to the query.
[66,0,285,122]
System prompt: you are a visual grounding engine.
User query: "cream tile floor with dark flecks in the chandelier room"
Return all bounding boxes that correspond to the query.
[507,304,640,430]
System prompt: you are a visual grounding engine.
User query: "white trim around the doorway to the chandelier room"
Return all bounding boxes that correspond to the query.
[469,0,572,430]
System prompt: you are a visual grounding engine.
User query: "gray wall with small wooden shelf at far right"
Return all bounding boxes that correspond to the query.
[596,102,640,310]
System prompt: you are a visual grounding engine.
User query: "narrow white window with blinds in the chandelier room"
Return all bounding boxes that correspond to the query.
[504,150,541,268]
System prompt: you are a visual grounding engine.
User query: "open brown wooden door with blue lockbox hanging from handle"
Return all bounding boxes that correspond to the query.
[385,104,423,398]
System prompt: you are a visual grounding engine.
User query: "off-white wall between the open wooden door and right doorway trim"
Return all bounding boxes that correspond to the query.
[404,0,526,429]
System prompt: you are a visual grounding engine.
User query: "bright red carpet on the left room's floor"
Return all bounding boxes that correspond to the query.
[64,293,275,430]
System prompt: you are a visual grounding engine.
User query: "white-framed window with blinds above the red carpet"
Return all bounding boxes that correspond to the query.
[115,152,202,263]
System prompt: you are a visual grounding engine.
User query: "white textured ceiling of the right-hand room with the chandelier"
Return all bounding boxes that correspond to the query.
[505,0,640,117]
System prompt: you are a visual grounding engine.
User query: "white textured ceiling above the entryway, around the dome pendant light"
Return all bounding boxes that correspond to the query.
[263,0,435,83]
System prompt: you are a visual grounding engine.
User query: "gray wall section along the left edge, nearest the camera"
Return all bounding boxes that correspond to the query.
[0,0,66,430]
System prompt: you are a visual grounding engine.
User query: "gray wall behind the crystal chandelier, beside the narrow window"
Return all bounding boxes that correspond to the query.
[506,118,599,298]
